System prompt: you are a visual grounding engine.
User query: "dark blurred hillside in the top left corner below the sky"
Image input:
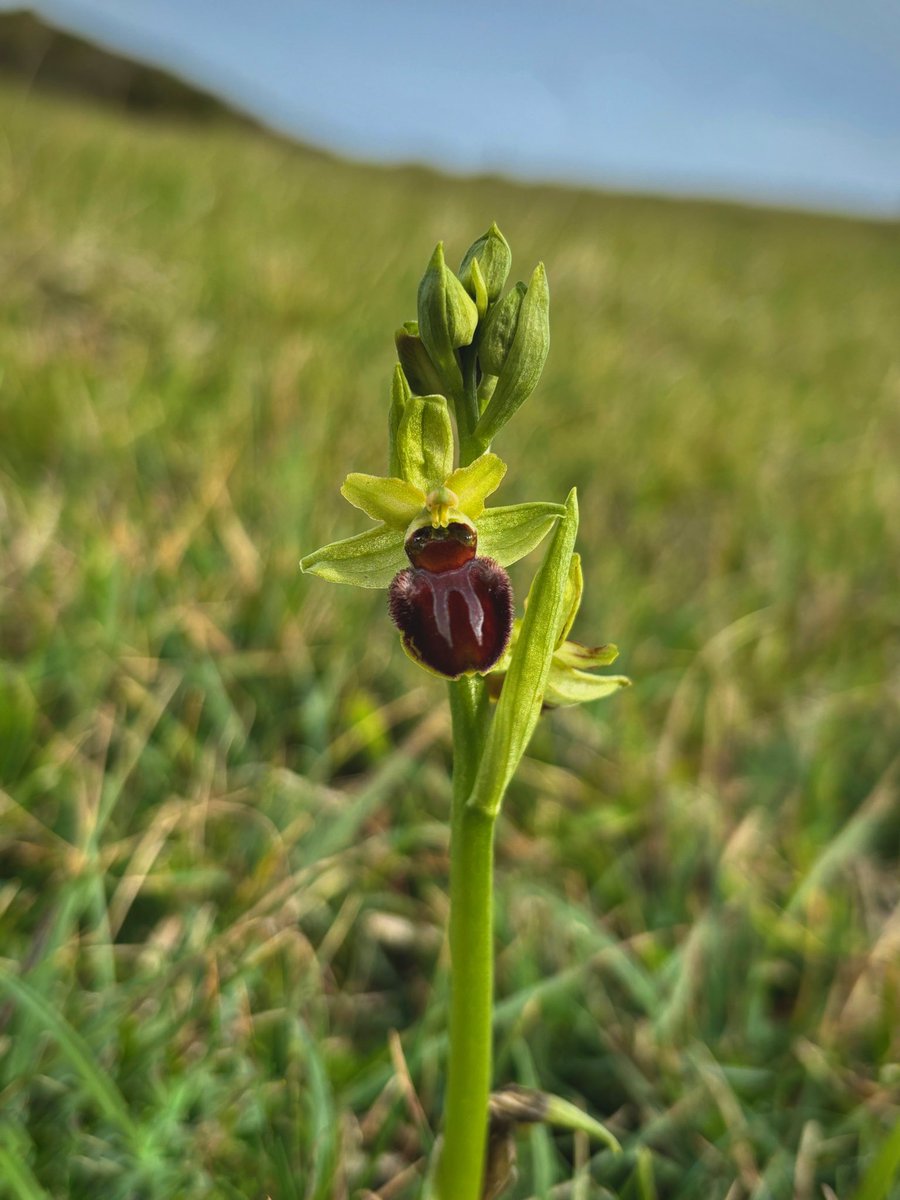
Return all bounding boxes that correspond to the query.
[0,11,245,120]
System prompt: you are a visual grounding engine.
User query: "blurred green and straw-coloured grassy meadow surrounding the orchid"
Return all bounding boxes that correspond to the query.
[0,84,900,1200]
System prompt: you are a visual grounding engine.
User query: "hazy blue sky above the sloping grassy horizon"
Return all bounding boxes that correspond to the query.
[7,0,900,216]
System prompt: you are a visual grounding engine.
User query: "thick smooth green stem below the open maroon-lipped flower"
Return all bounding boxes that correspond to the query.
[437,679,494,1200]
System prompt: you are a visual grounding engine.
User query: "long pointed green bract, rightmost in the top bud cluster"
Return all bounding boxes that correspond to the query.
[473,263,550,446]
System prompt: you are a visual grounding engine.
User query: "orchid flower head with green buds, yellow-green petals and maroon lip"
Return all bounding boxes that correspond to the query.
[301,224,628,706]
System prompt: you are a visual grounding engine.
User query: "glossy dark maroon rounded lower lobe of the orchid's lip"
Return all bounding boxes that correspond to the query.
[390,553,512,679]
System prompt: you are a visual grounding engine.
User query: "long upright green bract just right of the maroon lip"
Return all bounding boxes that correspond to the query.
[467,488,578,818]
